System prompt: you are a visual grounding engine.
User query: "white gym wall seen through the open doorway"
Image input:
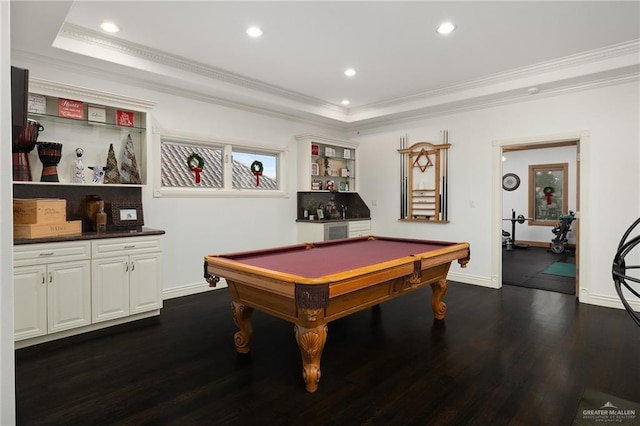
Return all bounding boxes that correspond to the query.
[502,146,578,244]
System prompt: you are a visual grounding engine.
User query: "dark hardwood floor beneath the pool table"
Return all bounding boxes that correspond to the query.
[16,282,640,426]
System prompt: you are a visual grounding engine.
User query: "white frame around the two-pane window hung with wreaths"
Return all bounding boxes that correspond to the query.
[153,129,289,198]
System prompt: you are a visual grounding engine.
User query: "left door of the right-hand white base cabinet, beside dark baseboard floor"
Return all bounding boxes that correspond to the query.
[91,256,130,322]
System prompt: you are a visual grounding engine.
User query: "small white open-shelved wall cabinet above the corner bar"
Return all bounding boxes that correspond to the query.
[296,134,358,192]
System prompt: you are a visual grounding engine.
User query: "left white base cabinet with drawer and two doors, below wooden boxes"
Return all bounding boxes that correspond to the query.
[14,241,91,341]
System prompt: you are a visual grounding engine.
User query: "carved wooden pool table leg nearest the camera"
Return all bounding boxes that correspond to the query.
[294,324,327,392]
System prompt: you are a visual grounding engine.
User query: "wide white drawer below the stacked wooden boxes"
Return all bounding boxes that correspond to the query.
[13,241,91,266]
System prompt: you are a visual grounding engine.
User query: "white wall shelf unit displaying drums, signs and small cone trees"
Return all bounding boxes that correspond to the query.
[13,78,155,186]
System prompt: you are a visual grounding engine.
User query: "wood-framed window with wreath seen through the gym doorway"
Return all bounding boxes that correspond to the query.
[529,163,569,226]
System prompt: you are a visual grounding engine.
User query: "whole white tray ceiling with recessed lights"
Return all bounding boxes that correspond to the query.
[11,0,640,127]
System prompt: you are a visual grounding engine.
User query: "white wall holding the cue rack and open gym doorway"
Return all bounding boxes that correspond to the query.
[353,81,640,307]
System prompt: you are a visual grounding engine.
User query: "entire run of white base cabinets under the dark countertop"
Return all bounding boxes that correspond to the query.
[13,233,162,348]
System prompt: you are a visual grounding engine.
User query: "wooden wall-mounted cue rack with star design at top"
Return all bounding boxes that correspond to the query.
[398,130,451,223]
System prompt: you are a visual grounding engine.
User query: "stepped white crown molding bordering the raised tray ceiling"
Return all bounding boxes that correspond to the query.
[20,24,640,131]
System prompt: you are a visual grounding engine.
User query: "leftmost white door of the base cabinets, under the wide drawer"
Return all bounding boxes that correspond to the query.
[13,265,47,341]
